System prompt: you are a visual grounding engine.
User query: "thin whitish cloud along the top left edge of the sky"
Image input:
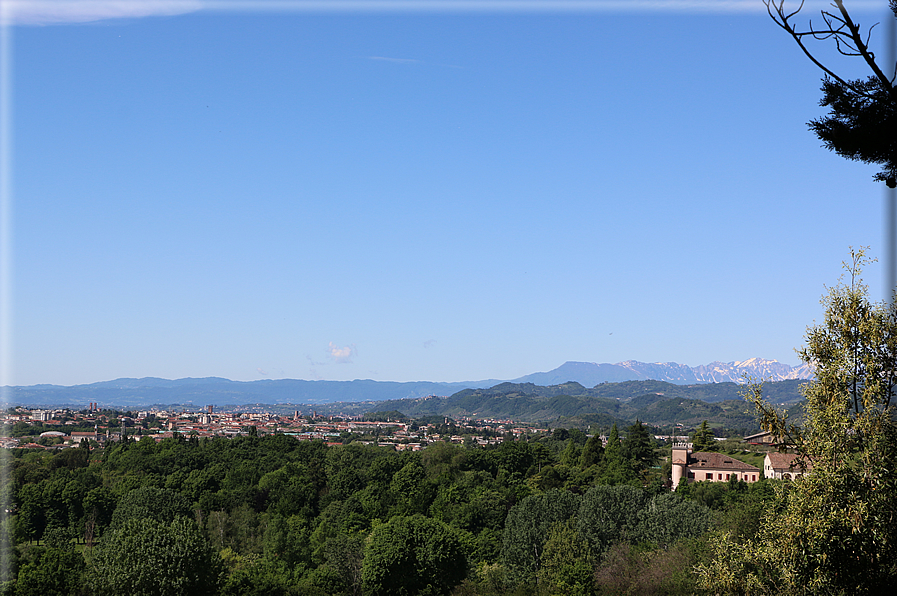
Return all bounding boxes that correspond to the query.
[2,0,203,25]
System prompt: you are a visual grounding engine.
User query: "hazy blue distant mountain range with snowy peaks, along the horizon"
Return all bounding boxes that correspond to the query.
[1,358,812,408]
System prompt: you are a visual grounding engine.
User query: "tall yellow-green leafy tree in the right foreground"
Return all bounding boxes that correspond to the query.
[701,250,897,594]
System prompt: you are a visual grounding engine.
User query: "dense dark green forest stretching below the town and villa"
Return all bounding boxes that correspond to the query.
[2,424,772,595]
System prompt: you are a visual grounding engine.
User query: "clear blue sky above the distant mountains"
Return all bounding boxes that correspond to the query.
[4,0,887,385]
